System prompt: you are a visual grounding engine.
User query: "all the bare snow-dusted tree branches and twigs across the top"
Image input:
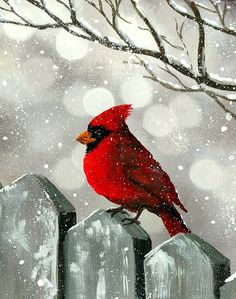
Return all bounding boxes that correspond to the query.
[0,0,236,119]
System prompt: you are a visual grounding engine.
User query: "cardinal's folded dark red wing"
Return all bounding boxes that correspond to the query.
[119,134,187,211]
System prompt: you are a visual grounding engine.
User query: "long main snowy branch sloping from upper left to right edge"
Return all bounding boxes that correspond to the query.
[0,0,236,91]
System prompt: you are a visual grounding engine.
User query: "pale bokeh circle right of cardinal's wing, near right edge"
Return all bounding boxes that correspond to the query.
[189,159,224,191]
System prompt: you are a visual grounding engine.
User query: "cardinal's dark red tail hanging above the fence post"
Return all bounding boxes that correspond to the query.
[150,205,191,237]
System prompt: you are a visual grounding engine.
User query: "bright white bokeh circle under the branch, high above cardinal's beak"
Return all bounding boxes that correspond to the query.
[56,30,88,60]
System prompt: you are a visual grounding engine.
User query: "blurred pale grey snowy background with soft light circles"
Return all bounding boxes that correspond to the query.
[0,1,236,272]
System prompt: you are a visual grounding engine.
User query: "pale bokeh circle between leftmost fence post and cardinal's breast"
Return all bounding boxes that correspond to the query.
[52,158,85,190]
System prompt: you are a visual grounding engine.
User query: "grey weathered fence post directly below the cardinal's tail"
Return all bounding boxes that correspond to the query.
[145,234,230,299]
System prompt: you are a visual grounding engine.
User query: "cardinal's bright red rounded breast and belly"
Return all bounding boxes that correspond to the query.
[84,133,152,206]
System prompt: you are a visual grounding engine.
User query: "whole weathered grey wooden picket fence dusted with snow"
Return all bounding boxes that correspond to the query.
[0,175,236,299]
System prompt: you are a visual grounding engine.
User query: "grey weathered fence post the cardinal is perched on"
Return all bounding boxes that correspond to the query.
[65,210,151,299]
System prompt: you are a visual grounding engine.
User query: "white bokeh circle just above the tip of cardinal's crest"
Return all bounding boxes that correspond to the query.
[121,76,153,108]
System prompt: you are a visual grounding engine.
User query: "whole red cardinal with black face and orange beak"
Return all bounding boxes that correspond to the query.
[77,105,191,236]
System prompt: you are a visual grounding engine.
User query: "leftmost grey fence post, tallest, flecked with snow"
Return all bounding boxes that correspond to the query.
[0,175,75,299]
